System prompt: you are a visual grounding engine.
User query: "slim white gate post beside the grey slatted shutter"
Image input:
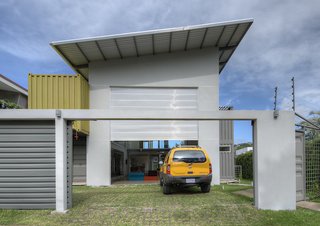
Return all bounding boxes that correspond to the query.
[55,118,67,212]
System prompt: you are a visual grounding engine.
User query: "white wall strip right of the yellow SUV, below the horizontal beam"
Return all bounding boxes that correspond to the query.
[199,121,220,185]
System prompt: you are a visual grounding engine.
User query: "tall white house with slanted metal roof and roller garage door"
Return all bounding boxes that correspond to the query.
[30,20,253,186]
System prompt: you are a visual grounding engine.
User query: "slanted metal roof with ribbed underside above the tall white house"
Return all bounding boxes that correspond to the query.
[50,19,253,77]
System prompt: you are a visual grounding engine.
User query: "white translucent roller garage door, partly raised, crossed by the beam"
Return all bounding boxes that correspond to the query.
[110,87,198,141]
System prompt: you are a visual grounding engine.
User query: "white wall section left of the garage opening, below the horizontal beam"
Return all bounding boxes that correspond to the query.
[87,121,111,186]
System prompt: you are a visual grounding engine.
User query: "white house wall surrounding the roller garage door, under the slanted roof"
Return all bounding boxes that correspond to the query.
[87,48,220,185]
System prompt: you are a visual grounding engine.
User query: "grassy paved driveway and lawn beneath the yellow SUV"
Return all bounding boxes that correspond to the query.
[0,185,320,225]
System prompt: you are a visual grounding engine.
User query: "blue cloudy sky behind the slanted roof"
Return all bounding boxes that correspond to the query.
[0,0,320,143]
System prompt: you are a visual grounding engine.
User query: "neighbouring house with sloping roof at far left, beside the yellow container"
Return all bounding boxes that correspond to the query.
[0,74,28,108]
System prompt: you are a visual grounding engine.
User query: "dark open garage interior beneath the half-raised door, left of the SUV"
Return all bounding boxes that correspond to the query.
[111,140,198,184]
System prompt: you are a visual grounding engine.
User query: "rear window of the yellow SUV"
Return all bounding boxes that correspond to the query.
[172,150,206,163]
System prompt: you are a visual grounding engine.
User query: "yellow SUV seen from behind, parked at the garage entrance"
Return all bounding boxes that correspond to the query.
[160,146,212,194]
